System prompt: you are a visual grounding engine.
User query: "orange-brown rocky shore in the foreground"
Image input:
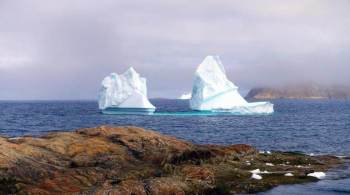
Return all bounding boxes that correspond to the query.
[0,126,342,195]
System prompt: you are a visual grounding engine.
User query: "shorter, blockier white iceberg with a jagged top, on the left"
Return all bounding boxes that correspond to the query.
[98,67,156,114]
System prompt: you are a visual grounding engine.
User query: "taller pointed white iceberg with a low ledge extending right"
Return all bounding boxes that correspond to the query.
[190,56,273,114]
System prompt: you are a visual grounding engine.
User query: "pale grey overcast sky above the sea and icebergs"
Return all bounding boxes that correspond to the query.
[0,0,350,99]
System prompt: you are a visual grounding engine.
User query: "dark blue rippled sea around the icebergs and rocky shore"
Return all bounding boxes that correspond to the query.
[0,99,350,194]
